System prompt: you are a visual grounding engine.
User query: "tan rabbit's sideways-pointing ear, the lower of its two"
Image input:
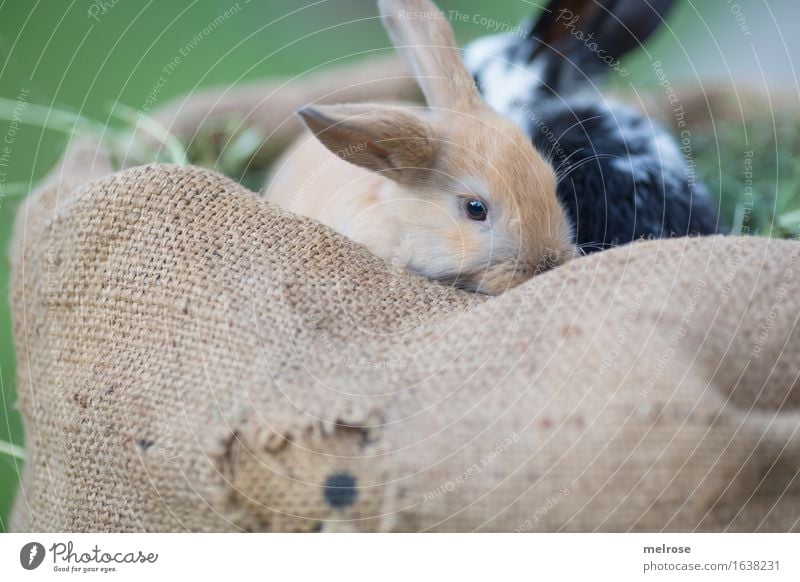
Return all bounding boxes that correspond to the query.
[298,104,435,181]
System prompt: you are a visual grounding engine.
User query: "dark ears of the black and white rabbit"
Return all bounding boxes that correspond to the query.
[530,0,675,62]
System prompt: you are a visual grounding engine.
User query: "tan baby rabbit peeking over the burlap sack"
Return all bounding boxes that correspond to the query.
[267,0,573,294]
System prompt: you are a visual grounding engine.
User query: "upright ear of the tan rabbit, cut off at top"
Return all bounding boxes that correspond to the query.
[378,0,480,110]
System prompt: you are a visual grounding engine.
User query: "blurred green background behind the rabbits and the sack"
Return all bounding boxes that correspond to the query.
[0,0,800,531]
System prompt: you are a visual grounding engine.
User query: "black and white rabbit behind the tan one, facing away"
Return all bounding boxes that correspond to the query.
[465,0,724,253]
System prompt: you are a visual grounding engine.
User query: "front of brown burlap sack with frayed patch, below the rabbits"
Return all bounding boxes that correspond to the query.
[7,57,800,531]
